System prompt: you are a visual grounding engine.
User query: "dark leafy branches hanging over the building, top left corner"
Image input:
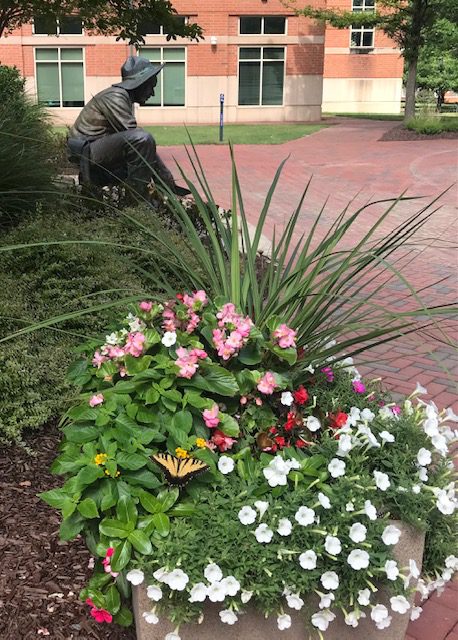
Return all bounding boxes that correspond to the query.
[0,0,202,45]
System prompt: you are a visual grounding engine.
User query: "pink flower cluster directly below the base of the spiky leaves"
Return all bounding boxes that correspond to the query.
[213,302,253,360]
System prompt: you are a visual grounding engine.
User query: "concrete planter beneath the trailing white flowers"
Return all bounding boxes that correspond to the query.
[133,522,425,640]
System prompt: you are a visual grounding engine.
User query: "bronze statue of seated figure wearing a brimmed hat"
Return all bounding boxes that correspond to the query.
[68,56,176,193]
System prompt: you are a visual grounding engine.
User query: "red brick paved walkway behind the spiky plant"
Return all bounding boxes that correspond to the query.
[161,120,458,640]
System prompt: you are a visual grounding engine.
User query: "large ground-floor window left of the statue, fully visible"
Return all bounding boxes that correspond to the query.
[35,47,84,107]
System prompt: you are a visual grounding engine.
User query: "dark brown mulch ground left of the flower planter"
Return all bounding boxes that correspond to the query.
[0,425,135,640]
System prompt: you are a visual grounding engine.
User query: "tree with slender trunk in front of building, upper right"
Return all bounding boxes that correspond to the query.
[282,0,458,119]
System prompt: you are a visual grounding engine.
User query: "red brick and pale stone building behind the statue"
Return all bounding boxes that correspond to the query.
[0,0,402,124]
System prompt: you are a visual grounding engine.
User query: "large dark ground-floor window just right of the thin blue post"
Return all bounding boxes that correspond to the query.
[239,47,285,106]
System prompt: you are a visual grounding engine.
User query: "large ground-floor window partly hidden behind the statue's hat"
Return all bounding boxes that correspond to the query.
[139,47,186,107]
